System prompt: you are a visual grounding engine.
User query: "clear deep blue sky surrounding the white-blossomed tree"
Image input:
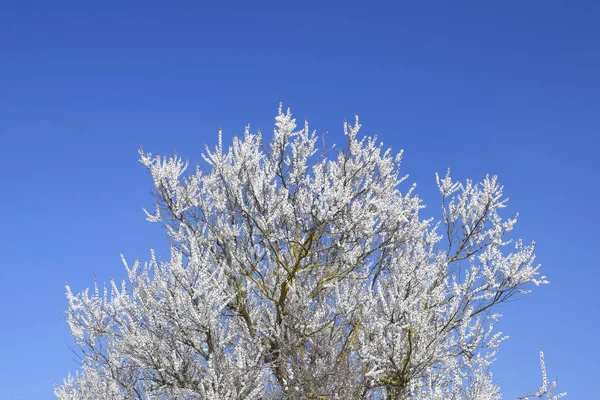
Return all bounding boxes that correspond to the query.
[0,1,600,400]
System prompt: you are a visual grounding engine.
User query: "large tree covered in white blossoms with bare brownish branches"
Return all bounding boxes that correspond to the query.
[55,104,564,400]
